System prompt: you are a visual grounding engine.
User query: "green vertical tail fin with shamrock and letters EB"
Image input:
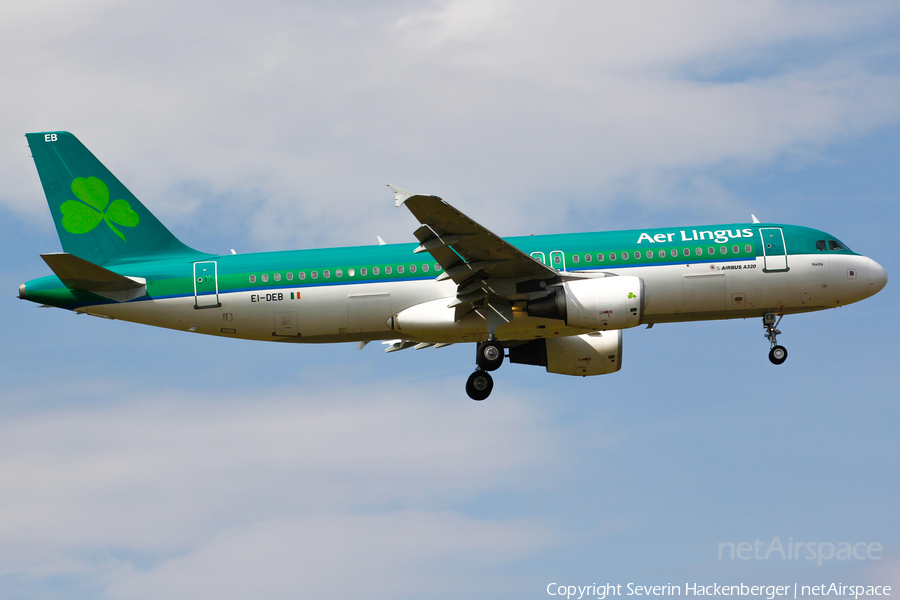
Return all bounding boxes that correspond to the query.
[25,131,200,265]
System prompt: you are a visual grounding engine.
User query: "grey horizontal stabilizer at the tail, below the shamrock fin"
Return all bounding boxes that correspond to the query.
[41,252,147,302]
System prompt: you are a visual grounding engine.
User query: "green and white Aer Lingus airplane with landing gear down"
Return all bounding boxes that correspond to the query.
[19,131,887,400]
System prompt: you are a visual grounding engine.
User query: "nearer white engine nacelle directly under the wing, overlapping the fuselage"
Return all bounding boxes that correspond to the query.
[528,275,644,331]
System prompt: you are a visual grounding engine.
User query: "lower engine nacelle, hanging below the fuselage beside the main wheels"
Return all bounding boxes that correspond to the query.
[509,329,622,377]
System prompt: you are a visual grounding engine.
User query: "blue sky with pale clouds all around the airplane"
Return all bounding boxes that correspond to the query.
[0,0,900,599]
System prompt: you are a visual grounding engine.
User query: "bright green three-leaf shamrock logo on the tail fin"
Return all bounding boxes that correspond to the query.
[60,177,141,241]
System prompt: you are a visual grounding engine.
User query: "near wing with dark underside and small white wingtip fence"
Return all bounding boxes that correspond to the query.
[388,185,558,284]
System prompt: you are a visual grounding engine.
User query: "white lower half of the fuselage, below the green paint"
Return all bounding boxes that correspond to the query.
[76,254,883,343]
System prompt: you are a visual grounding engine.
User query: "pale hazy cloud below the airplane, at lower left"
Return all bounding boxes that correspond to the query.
[0,381,576,598]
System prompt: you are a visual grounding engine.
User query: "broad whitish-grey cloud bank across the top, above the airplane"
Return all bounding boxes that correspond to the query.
[0,0,900,247]
